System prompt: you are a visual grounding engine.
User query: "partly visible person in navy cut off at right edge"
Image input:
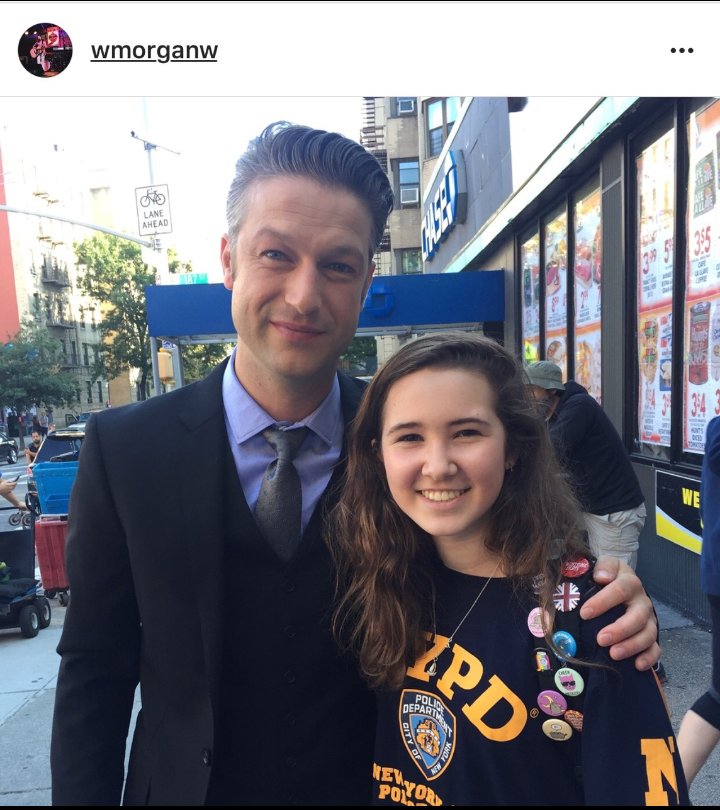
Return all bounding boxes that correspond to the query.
[678,416,720,785]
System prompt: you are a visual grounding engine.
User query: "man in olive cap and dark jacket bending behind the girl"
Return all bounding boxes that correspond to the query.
[525,360,646,568]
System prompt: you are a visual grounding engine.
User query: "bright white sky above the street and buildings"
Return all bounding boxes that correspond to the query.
[0,96,594,281]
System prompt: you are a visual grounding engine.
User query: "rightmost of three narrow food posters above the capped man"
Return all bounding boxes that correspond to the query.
[573,182,602,403]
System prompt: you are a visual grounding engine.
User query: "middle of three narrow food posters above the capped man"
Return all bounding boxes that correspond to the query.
[545,211,567,380]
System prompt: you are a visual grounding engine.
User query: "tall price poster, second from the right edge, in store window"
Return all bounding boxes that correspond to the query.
[635,130,675,447]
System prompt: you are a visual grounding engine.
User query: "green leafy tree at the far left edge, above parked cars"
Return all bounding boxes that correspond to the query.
[0,319,76,438]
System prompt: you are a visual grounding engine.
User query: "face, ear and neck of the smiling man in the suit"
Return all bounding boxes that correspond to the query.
[221,177,374,400]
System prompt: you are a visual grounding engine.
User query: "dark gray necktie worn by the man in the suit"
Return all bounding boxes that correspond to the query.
[255,428,308,560]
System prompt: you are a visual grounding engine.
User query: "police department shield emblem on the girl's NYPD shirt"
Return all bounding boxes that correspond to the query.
[399,689,455,779]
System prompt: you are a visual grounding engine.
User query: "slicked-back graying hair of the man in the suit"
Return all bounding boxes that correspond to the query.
[226,121,393,259]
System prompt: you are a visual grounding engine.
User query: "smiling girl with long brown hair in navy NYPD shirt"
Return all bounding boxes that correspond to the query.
[327,333,689,807]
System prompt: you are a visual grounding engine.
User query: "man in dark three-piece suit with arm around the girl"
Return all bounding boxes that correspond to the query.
[51,118,657,805]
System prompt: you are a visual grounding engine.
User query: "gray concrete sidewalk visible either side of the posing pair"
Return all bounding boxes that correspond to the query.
[0,599,720,807]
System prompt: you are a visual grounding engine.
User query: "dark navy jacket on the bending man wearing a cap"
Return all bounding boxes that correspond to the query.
[549,380,645,515]
